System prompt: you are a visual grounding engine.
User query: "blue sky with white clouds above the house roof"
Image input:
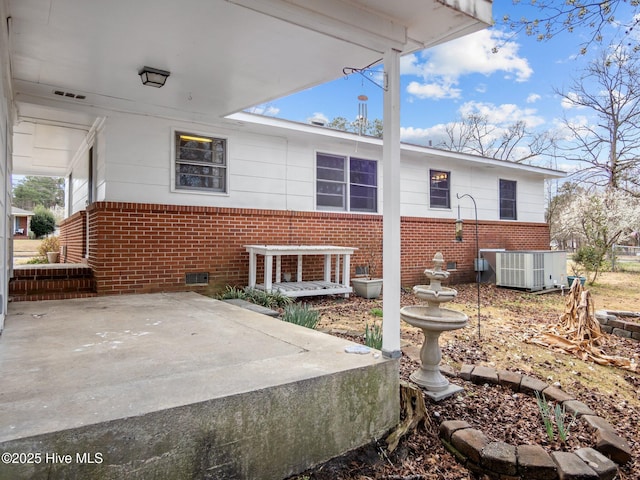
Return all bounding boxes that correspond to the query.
[248,0,627,170]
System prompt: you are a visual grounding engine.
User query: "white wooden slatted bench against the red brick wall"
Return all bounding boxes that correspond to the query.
[244,245,357,297]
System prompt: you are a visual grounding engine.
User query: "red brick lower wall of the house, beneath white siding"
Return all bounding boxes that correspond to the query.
[61,202,549,294]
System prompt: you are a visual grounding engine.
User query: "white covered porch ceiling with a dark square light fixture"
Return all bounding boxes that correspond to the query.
[5,0,491,176]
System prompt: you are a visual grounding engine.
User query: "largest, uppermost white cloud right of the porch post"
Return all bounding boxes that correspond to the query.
[400,30,533,98]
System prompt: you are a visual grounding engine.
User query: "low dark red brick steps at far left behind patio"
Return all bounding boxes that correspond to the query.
[9,264,97,302]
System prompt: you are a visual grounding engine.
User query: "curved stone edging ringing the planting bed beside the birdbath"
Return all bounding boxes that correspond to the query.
[440,365,631,480]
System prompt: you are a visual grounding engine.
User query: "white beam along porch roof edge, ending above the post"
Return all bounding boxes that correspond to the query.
[227,0,407,54]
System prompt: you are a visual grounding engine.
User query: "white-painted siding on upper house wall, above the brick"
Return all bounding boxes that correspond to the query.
[69,113,563,223]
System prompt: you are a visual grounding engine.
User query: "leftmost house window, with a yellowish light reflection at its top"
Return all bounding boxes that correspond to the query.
[175,132,227,193]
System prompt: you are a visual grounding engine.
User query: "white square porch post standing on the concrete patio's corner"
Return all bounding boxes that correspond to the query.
[382,49,401,358]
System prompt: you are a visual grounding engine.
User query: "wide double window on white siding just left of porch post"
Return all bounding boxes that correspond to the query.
[316,153,378,213]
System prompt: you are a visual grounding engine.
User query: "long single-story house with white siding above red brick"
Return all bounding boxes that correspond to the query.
[55,113,563,294]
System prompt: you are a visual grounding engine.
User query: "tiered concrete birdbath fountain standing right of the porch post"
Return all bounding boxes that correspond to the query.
[400,252,469,401]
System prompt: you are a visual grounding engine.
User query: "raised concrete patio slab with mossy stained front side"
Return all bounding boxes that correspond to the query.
[0,293,399,479]
